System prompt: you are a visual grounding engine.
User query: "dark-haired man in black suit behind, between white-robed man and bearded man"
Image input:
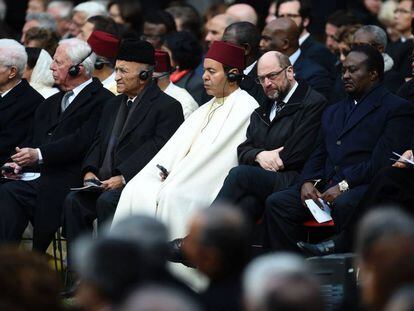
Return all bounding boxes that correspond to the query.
[223,22,267,105]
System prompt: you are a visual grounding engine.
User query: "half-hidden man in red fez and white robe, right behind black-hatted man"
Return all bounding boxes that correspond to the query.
[154,50,198,119]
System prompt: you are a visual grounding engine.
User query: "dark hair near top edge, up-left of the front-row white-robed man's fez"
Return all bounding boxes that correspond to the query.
[165,4,201,38]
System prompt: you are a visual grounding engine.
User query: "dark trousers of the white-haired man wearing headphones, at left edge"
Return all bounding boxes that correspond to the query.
[0,179,40,244]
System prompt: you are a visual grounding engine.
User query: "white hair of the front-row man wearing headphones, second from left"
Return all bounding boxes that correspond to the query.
[59,38,96,78]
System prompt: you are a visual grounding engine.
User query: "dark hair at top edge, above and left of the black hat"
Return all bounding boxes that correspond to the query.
[108,0,143,33]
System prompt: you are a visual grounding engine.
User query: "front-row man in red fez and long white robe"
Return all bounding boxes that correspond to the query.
[114,41,258,286]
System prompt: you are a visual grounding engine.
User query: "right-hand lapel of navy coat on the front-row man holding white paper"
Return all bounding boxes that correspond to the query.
[339,87,385,137]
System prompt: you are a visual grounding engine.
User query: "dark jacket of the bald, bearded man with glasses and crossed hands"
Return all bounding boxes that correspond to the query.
[237,82,326,171]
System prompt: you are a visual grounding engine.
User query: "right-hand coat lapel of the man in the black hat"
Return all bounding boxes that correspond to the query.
[119,83,158,142]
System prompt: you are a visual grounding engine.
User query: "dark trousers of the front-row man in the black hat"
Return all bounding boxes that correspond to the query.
[63,188,122,244]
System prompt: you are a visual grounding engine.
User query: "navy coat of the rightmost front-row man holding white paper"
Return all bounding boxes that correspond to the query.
[301,85,414,188]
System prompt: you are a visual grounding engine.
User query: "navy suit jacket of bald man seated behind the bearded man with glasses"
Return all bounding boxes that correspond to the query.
[293,53,334,101]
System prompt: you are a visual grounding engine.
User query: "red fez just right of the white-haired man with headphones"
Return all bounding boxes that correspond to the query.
[88,30,119,59]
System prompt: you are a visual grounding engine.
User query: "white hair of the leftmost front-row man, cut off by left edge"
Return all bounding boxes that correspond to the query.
[0,39,27,79]
